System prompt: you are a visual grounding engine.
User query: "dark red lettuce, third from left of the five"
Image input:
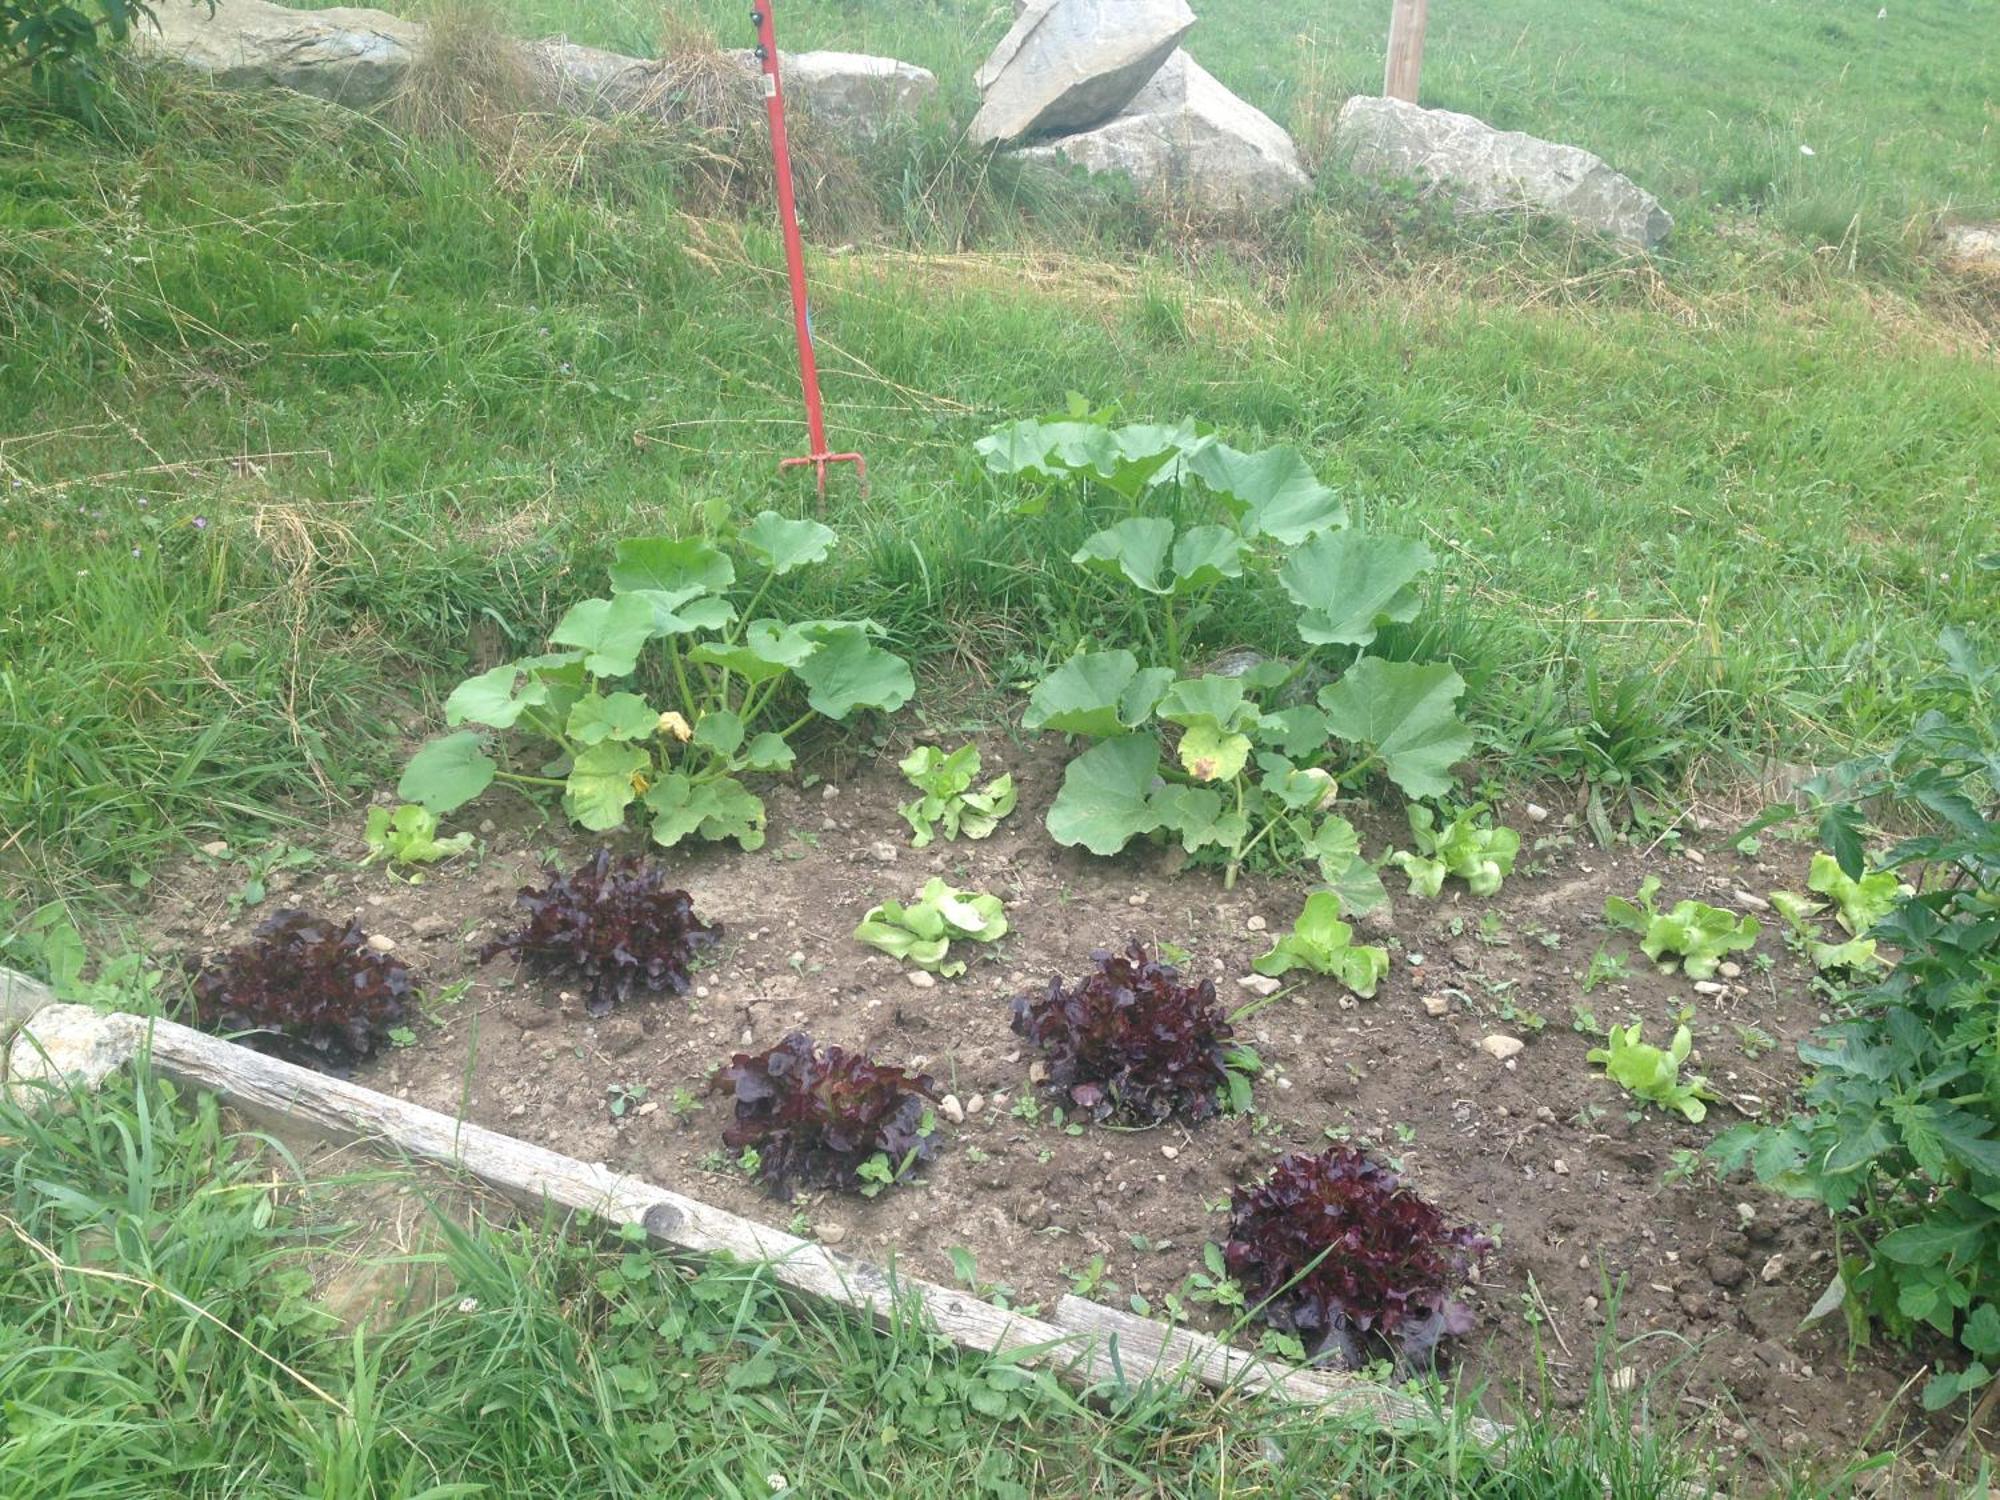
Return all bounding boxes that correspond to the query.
[714,1032,938,1196]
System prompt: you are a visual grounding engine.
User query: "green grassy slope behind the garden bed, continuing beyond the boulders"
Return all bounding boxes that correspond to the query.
[0,0,2000,916]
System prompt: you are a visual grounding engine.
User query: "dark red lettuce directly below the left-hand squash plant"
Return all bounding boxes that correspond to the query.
[480,848,722,1016]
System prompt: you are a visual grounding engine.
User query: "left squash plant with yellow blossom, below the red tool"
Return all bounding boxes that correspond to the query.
[396,510,914,850]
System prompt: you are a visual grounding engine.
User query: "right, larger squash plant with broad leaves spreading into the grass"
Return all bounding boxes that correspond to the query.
[978,412,1472,892]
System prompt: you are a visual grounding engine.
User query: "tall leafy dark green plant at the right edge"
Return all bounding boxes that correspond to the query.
[1712,632,2000,1406]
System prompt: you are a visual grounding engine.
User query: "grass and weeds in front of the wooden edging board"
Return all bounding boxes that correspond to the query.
[0,1072,1856,1500]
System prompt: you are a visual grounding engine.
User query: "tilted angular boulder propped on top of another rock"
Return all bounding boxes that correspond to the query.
[972,0,1194,144]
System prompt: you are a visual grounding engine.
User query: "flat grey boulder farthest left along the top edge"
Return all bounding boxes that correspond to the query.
[132,0,424,110]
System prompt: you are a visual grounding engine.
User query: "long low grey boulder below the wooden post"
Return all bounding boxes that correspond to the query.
[1334,96,1674,250]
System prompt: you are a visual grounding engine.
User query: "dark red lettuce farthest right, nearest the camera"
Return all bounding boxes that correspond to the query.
[1224,1146,1492,1368]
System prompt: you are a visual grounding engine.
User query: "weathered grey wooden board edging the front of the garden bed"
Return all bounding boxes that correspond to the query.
[3,980,1504,1438]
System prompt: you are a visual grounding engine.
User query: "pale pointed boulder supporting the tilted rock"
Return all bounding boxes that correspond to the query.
[1020,52,1312,218]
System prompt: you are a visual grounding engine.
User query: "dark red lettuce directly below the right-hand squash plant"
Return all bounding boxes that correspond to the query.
[1014,942,1230,1124]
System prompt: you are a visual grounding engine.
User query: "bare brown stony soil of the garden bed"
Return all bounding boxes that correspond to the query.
[137,738,1950,1488]
